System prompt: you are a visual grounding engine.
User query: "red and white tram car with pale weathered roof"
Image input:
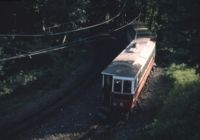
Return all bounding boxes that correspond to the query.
[101,24,156,112]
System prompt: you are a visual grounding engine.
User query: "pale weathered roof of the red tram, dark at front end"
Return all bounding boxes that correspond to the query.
[102,26,155,78]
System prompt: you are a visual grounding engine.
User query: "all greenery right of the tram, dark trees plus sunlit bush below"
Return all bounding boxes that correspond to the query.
[135,0,200,137]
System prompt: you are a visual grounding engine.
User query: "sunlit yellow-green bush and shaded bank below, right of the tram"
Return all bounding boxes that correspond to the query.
[138,64,200,140]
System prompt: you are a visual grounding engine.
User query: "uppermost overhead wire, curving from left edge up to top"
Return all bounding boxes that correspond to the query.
[0,0,128,37]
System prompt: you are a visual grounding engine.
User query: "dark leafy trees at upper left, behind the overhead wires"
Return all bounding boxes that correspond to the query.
[0,0,89,96]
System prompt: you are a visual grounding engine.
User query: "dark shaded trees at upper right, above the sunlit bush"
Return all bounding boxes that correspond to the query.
[144,0,200,66]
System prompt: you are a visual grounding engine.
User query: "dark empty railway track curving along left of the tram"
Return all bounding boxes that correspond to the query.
[1,37,122,140]
